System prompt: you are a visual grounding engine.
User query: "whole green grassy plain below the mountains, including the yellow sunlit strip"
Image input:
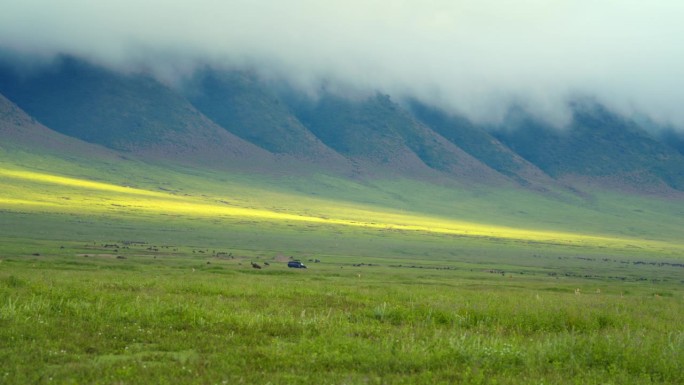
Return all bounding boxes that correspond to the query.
[0,149,684,384]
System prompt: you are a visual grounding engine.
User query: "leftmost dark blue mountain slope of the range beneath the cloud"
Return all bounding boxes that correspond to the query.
[0,57,270,162]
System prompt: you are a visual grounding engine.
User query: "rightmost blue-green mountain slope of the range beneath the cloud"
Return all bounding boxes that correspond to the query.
[495,102,684,190]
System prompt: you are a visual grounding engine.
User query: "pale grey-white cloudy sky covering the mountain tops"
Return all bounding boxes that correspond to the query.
[0,0,684,128]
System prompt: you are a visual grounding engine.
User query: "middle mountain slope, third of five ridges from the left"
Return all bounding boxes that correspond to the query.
[294,94,504,183]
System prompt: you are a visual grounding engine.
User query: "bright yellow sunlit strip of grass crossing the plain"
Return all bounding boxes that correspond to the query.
[0,169,670,250]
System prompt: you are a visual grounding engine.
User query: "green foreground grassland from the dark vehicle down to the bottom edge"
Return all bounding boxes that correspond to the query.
[0,248,684,384]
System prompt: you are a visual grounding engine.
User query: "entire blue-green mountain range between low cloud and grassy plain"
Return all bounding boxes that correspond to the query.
[0,51,684,194]
